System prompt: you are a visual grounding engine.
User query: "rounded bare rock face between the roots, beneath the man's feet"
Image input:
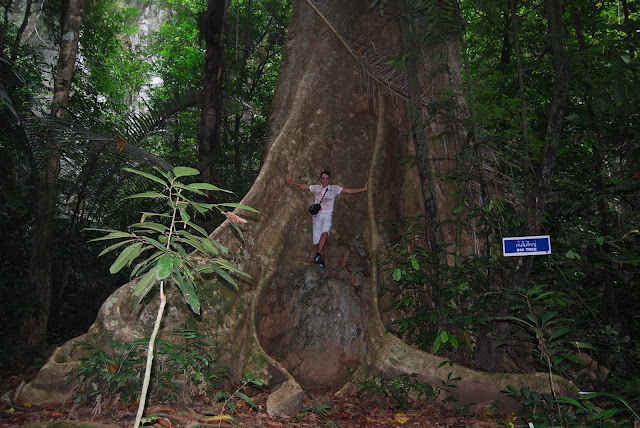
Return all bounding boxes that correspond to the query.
[257,246,371,388]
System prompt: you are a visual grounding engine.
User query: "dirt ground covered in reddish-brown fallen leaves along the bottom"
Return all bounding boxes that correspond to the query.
[0,373,515,428]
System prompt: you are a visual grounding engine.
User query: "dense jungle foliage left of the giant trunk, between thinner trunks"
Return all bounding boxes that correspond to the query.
[0,0,291,364]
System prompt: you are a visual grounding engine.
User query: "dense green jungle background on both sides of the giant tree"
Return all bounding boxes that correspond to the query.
[0,0,640,424]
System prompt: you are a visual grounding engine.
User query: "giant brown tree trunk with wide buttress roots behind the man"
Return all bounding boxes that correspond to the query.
[21,0,572,406]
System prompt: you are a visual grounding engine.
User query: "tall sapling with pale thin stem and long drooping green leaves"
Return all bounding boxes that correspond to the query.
[90,167,257,428]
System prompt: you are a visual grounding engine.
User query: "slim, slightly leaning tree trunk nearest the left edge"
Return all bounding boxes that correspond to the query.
[22,0,85,348]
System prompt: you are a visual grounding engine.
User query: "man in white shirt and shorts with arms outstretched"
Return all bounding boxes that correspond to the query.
[286,171,367,267]
